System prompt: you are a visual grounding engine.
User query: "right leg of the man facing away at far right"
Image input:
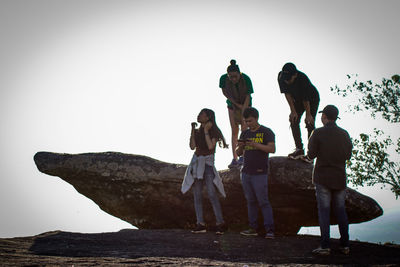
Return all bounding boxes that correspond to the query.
[332,189,349,247]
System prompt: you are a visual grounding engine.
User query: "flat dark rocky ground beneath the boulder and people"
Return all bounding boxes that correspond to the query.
[0,230,400,266]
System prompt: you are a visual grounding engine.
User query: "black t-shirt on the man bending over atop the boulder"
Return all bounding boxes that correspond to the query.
[278,71,319,102]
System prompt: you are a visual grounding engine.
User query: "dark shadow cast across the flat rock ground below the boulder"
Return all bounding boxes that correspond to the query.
[30,230,400,266]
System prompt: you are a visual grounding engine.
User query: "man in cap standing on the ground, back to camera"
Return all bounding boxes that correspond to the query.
[305,105,353,255]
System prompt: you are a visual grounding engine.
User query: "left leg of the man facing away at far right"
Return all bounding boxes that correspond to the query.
[315,184,332,248]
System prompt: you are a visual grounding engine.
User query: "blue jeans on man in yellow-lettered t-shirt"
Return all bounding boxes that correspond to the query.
[241,172,274,233]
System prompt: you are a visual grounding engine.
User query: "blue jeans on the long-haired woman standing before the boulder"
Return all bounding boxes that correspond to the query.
[193,165,224,225]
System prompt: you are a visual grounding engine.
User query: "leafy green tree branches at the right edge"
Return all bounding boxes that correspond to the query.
[331,75,400,198]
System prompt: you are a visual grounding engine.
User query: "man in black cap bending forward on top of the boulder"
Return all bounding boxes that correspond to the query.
[278,63,319,159]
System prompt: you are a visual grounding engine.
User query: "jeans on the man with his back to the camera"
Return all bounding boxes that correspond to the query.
[315,184,349,248]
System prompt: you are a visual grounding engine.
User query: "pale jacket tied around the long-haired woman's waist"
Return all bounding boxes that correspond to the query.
[181,154,226,197]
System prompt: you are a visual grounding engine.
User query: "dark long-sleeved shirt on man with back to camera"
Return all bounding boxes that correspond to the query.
[307,122,353,190]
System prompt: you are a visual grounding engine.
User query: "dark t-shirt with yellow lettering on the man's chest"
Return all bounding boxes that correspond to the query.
[240,125,275,175]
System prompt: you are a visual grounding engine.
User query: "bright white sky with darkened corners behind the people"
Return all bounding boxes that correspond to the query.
[0,0,400,242]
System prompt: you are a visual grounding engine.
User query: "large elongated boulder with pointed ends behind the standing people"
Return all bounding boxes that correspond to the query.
[34,152,383,234]
